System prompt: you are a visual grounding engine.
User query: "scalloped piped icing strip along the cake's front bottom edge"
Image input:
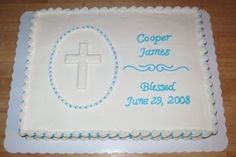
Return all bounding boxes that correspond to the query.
[20,130,212,141]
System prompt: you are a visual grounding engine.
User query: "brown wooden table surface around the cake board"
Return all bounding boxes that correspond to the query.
[0,0,236,157]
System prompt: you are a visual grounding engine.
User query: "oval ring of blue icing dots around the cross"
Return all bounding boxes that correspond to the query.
[48,25,119,109]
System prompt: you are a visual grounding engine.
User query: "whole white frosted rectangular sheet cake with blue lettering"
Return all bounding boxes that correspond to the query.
[19,7,217,140]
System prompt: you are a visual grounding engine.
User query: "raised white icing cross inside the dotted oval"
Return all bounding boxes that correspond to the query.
[65,43,101,89]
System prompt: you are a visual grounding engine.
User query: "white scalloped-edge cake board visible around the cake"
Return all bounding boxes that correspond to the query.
[4,11,228,153]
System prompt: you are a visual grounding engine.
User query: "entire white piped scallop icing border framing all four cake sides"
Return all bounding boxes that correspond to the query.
[18,6,218,141]
